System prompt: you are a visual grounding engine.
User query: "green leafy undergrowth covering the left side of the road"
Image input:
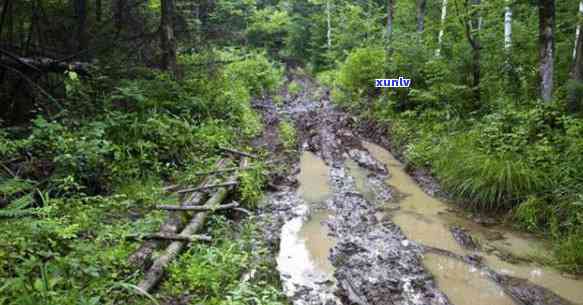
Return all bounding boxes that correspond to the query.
[0,51,282,304]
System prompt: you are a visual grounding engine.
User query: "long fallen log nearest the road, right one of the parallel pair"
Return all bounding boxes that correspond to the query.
[138,158,247,292]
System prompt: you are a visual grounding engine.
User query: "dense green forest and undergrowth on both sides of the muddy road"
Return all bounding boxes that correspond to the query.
[0,0,583,304]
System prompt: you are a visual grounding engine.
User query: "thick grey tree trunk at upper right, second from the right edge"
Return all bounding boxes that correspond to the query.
[539,0,555,102]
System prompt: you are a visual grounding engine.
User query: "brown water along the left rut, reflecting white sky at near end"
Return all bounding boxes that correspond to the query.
[277,151,336,304]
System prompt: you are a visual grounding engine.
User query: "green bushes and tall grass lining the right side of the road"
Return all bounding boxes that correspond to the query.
[308,1,583,273]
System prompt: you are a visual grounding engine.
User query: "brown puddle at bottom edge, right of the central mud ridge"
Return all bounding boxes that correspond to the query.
[423,253,514,305]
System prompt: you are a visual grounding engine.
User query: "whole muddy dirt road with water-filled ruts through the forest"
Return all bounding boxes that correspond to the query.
[255,73,583,305]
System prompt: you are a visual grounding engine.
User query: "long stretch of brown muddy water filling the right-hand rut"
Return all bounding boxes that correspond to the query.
[363,142,583,305]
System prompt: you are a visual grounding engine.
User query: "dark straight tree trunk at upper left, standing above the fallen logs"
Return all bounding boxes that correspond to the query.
[160,0,177,76]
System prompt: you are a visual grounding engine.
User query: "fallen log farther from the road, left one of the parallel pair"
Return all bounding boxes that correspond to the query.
[129,159,226,267]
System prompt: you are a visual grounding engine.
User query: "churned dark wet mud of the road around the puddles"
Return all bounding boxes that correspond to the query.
[256,70,571,305]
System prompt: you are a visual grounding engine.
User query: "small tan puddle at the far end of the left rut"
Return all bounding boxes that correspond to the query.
[298,151,331,203]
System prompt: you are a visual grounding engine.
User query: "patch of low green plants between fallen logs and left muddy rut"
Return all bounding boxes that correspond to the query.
[162,216,284,305]
